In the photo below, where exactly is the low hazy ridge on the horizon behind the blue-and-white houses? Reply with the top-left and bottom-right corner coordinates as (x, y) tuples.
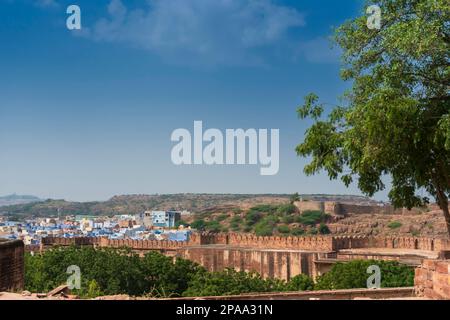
(0, 194), (370, 218)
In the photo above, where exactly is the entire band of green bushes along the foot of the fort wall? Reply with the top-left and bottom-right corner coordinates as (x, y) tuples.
(25, 247), (414, 297)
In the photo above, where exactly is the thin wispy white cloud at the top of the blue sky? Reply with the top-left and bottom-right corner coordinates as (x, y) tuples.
(89, 0), (305, 65)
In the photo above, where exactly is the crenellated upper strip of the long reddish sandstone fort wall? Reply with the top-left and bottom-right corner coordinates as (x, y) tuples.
(36, 232), (450, 251)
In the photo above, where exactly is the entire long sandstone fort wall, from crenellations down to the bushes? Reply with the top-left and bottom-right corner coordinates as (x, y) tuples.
(26, 233), (450, 280)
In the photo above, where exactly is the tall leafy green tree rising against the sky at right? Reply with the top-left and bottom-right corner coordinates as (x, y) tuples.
(296, 0), (450, 234)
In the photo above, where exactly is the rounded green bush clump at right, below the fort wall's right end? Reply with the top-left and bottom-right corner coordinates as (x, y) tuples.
(314, 260), (414, 290)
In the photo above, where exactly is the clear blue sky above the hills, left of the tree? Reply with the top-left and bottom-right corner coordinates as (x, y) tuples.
(0, 0), (385, 201)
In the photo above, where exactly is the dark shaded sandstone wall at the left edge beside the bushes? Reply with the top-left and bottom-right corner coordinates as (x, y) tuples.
(0, 240), (24, 291)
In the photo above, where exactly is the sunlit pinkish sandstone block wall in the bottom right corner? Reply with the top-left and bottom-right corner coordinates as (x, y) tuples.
(414, 260), (450, 299)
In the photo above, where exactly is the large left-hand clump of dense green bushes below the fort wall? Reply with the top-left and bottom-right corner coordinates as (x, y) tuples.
(25, 247), (203, 298)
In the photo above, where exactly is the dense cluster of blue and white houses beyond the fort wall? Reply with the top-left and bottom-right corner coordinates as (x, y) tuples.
(0, 210), (191, 245)
